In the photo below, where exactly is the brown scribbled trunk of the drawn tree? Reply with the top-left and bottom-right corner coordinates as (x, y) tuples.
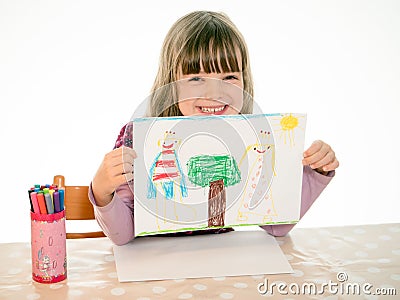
(208, 179), (226, 227)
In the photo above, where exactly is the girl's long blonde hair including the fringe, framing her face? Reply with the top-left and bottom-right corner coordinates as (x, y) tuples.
(146, 11), (253, 117)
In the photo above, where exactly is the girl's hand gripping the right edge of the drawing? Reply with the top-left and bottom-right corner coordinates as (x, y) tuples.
(303, 140), (339, 175)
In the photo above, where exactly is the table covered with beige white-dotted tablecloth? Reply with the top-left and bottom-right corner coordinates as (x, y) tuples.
(0, 224), (400, 300)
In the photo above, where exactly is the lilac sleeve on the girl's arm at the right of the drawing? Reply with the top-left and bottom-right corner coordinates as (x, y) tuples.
(261, 166), (335, 236)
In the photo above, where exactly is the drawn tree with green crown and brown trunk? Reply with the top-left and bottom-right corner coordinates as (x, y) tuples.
(186, 155), (241, 227)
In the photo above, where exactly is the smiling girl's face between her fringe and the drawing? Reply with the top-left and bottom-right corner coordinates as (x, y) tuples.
(177, 71), (243, 116)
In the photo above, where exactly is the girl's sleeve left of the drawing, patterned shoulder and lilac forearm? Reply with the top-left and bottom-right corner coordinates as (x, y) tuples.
(89, 123), (135, 245)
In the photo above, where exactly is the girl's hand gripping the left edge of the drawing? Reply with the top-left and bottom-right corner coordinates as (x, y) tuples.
(92, 146), (137, 206)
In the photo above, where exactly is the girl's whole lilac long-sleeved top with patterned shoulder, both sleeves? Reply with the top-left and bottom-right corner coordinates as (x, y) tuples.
(89, 125), (335, 245)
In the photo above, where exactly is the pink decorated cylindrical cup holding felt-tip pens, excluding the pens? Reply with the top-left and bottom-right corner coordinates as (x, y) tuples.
(31, 210), (67, 283)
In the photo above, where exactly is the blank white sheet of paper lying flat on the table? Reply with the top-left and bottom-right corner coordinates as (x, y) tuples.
(113, 230), (293, 282)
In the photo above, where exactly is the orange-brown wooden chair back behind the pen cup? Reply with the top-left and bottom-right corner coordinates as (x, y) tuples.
(53, 175), (105, 239)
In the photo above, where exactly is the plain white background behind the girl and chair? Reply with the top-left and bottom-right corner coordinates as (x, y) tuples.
(0, 0), (400, 242)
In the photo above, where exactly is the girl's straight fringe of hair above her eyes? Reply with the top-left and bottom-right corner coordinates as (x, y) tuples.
(180, 22), (244, 75)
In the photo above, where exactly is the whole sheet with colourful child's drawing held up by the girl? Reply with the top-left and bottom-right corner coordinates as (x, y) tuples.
(133, 114), (306, 236)
